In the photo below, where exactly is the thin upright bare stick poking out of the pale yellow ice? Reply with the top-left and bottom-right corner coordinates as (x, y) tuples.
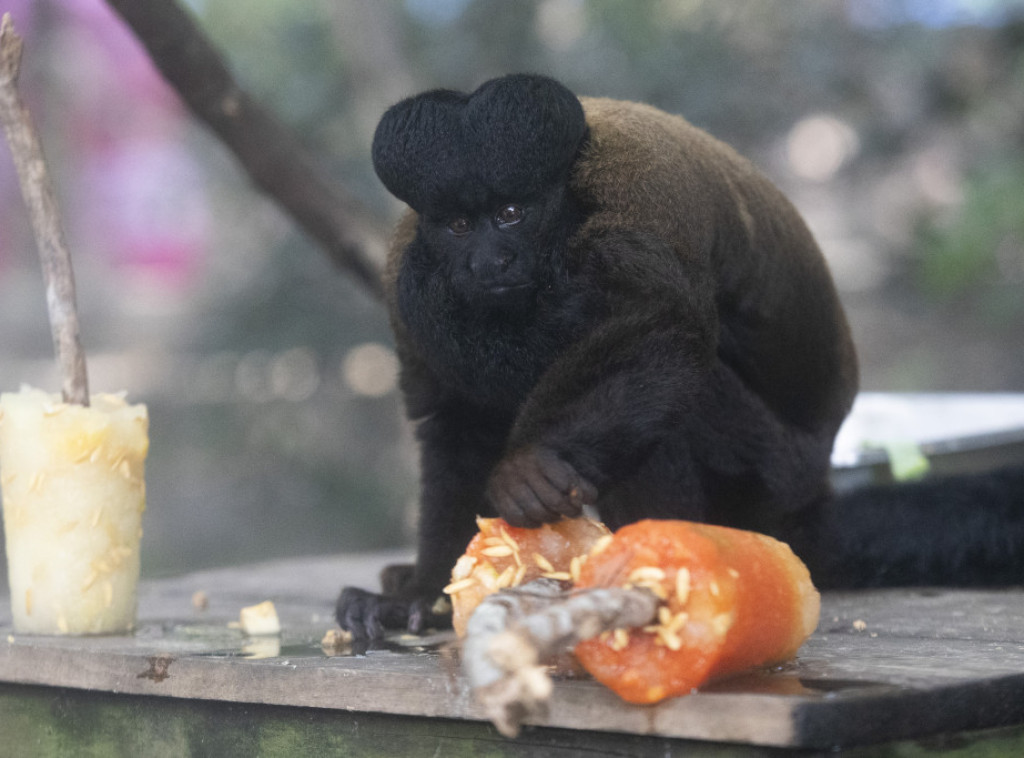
(0, 13), (89, 406)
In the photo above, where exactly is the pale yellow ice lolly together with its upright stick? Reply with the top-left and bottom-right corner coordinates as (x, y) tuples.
(0, 13), (150, 634)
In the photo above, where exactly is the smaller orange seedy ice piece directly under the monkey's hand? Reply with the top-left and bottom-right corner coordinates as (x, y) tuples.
(444, 518), (611, 637)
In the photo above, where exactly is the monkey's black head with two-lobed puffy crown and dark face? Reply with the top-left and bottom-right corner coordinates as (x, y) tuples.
(373, 74), (587, 306)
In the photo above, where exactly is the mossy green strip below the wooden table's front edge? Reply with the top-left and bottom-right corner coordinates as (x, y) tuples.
(0, 684), (806, 758)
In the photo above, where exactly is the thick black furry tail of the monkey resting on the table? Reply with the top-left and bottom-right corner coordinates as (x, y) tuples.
(787, 465), (1024, 589)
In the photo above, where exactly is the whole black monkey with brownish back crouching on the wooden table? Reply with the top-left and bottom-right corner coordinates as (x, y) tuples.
(338, 75), (1024, 637)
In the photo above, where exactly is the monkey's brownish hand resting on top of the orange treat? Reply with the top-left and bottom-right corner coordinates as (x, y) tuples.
(485, 447), (597, 528)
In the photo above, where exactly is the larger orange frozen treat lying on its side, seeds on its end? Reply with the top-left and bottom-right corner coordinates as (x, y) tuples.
(575, 520), (820, 703)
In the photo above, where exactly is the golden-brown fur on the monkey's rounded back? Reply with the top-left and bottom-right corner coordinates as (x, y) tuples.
(572, 97), (857, 434)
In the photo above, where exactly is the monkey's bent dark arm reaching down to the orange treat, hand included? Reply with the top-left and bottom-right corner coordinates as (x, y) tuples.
(486, 231), (718, 527)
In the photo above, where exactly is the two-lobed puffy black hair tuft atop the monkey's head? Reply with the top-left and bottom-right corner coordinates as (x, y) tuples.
(373, 74), (587, 215)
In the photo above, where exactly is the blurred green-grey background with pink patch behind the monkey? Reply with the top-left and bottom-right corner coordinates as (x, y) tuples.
(0, 0), (1024, 581)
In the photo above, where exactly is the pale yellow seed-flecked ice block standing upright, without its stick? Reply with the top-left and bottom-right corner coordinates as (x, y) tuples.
(0, 387), (150, 634)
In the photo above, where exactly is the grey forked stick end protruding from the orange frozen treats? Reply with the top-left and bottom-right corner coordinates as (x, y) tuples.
(462, 579), (659, 736)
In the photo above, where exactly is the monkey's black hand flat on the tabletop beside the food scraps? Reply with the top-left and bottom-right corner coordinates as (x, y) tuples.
(335, 587), (452, 640)
